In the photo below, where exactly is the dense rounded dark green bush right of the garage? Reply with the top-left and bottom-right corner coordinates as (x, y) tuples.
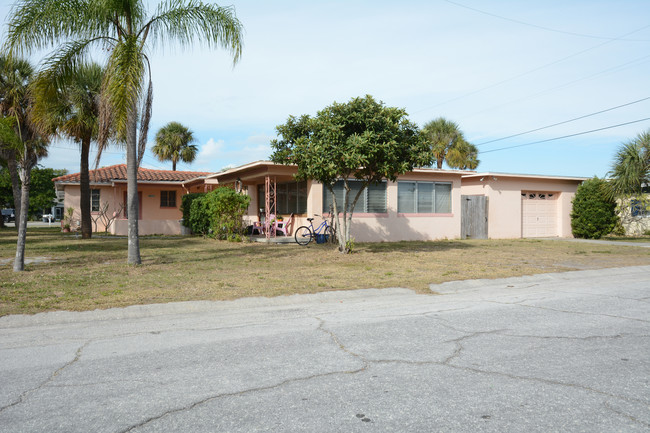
(571, 177), (619, 239)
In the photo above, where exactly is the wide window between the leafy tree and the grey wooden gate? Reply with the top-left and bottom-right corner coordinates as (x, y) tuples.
(397, 182), (451, 213)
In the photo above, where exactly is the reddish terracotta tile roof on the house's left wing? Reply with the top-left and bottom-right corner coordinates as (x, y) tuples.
(52, 164), (211, 183)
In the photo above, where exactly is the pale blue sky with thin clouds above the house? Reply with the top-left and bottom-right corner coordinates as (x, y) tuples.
(0, 0), (650, 177)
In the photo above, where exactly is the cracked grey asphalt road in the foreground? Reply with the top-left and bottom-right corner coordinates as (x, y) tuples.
(0, 266), (650, 433)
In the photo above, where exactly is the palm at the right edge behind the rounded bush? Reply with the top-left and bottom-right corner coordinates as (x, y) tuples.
(608, 129), (650, 196)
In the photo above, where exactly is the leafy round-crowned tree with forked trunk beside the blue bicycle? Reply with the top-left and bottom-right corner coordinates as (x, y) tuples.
(271, 95), (431, 253)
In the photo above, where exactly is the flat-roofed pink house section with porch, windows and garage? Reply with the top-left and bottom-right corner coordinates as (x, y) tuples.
(205, 161), (586, 242)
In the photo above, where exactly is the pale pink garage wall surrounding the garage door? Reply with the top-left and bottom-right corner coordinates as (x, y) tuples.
(462, 174), (579, 239)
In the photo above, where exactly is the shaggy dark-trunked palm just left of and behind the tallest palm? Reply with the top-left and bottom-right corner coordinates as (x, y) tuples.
(32, 63), (103, 239)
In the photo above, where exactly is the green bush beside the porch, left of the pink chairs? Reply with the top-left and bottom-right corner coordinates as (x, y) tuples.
(188, 187), (250, 241)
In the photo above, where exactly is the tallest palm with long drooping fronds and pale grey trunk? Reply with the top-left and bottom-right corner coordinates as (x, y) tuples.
(5, 0), (243, 264)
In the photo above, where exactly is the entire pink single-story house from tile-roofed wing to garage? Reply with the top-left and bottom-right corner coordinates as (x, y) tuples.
(54, 161), (585, 238)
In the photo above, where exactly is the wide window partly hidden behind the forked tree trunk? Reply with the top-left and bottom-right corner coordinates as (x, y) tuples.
(323, 179), (386, 213)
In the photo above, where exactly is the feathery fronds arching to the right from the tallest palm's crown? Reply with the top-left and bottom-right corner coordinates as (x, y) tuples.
(142, 0), (244, 63)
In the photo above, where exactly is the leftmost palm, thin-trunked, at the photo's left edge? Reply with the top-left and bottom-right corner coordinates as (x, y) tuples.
(0, 54), (49, 272)
